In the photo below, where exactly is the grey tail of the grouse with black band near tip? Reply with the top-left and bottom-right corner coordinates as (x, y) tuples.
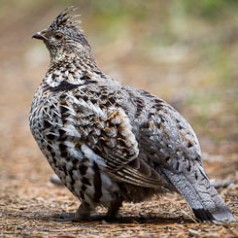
(162, 163), (235, 222)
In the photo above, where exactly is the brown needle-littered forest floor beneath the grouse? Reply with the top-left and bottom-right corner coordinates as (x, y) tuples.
(0, 148), (238, 238)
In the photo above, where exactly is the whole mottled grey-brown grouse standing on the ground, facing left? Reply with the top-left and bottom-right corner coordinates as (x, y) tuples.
(29, 7), (235, 222)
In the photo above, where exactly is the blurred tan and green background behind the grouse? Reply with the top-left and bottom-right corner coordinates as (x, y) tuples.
(0, 0), (238, 186)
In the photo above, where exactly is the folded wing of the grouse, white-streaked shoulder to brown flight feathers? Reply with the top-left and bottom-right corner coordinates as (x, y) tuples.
(60, 93), (164, 188)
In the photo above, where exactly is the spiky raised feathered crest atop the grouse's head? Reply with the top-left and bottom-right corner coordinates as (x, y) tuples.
(50, 6), (81, 29)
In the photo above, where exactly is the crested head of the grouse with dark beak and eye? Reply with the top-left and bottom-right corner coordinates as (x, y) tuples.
(32, 7), (91, 62)
